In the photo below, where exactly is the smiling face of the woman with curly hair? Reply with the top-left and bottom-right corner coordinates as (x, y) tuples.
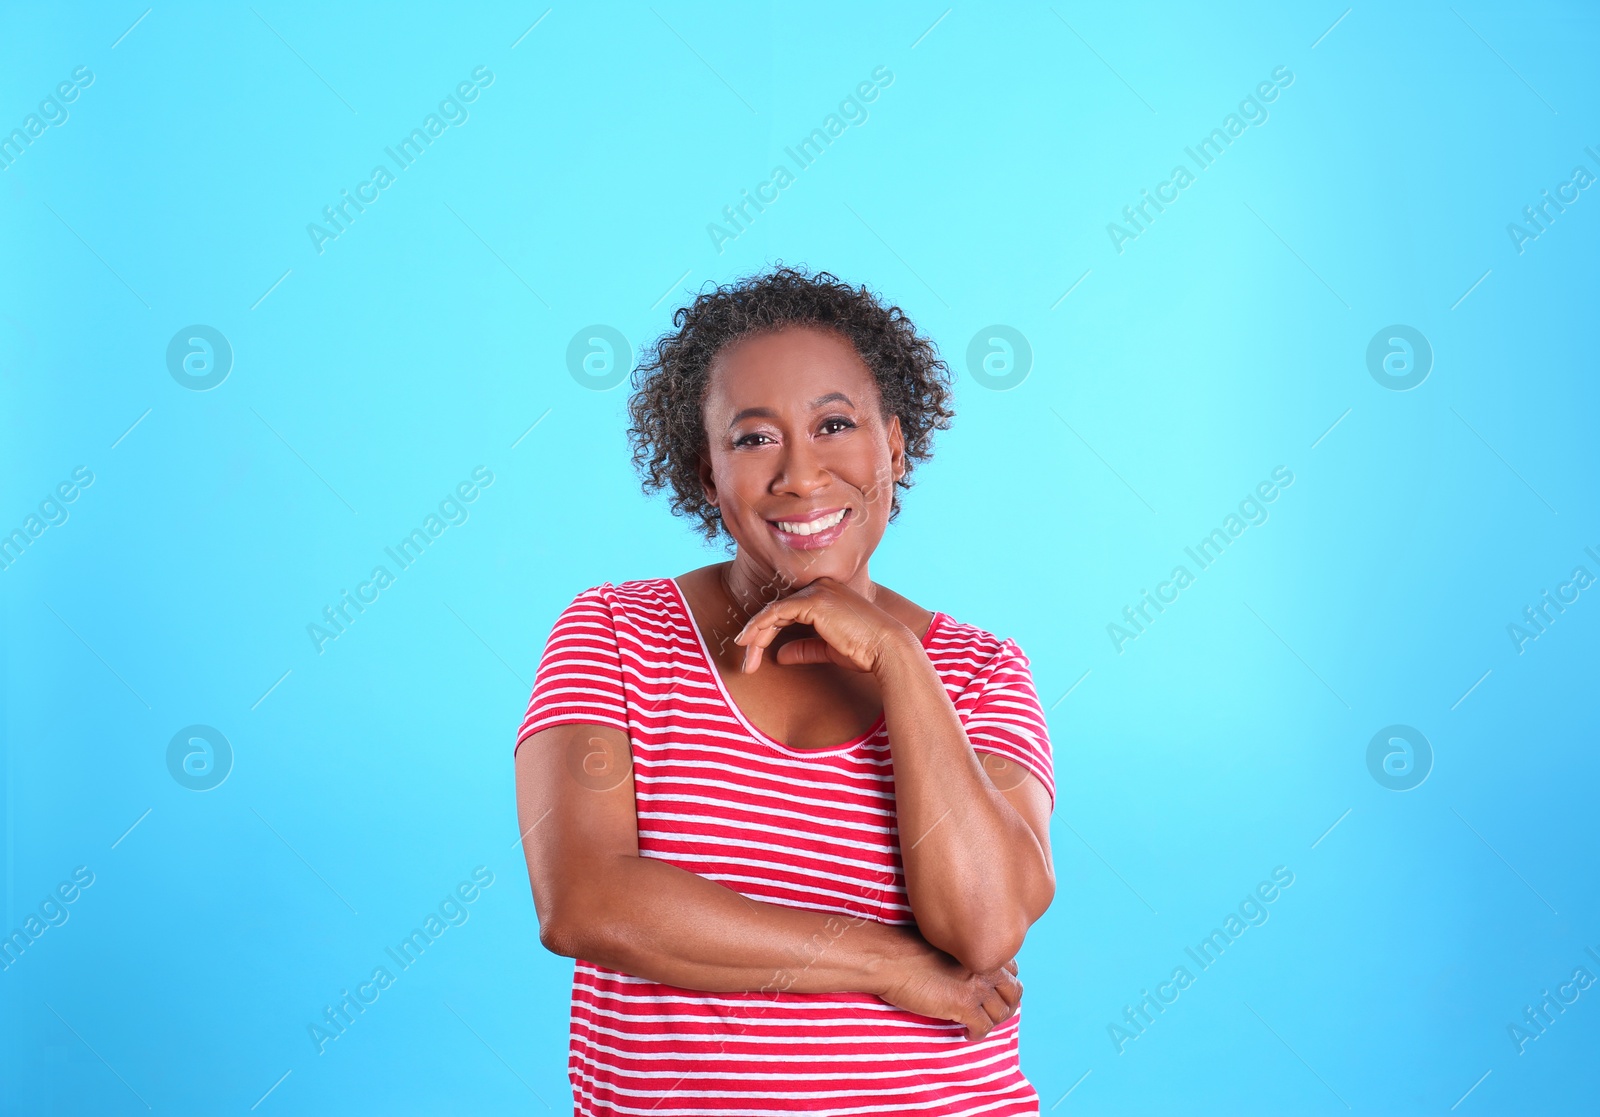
(701, 326), (906, 587)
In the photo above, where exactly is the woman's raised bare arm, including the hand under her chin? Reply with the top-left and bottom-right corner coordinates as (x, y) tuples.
(736, 578), (1056, 973)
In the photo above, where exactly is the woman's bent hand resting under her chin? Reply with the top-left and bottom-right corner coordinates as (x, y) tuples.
(733, 578), (917, 674)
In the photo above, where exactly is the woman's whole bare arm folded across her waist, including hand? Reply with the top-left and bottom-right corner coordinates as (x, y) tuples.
(517, 725), (1021, 1039)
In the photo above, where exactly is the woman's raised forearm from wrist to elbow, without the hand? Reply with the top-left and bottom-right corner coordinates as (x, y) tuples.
(880, 633), (1054, 968)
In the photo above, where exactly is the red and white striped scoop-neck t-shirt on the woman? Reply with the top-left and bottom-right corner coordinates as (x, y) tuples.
(517, 578), (1056, 1117)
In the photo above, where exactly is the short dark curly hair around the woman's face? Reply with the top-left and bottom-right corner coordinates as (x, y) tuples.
(627, 262), (955, 546)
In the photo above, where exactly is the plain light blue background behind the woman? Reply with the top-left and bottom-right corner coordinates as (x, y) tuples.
(0, 0), (1600, 1115)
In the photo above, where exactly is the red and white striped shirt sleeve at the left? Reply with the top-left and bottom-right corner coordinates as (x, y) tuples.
(512, 583), (627, 752)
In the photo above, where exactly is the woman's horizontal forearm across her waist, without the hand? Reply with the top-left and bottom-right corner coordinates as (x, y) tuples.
(542, 856), (914, 995)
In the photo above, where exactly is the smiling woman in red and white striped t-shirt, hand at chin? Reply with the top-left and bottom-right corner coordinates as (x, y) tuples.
(515, 267), (1054, 1115)
